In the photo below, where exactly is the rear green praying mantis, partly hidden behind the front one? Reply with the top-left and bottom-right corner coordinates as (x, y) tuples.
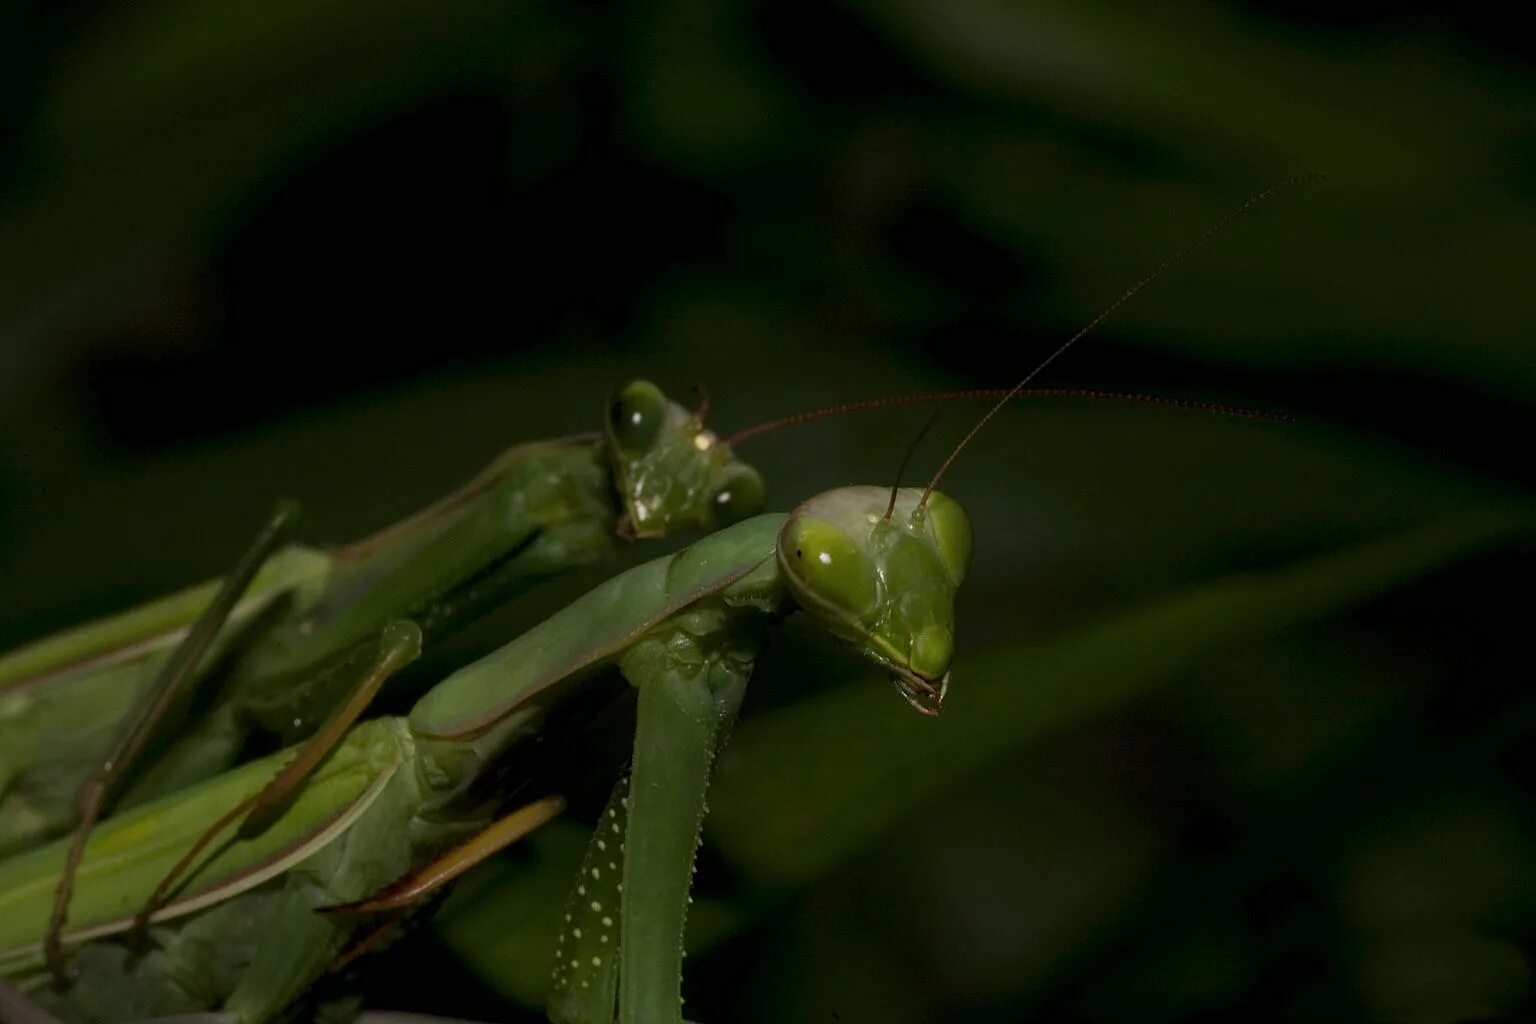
(0, 381), (763, 976)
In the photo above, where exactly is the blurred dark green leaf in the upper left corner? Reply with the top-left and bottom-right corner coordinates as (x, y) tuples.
(0, 0), (544, 329)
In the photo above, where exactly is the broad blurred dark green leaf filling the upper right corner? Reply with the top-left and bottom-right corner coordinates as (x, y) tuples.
(857, 0), (1536, 398)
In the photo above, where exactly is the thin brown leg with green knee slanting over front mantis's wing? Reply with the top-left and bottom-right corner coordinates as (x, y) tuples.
(137, 619), (421, 927)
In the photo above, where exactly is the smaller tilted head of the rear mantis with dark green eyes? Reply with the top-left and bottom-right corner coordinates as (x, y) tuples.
(605, 381), (766, 537)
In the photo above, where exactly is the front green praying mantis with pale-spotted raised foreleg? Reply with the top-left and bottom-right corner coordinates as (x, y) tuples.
(0, 186), (1296, 1024)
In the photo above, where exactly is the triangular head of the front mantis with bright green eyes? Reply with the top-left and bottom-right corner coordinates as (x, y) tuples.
(779, 487), (971, 714)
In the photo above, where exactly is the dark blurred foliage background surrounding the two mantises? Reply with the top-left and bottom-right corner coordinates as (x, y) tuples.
(0, 0), (1536, 1024)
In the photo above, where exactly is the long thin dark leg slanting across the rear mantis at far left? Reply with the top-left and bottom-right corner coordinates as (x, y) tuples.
(43, 502), (298, 983)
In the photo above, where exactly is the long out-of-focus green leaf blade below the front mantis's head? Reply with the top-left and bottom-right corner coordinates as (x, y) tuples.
(707, 513), (1519, 886)
